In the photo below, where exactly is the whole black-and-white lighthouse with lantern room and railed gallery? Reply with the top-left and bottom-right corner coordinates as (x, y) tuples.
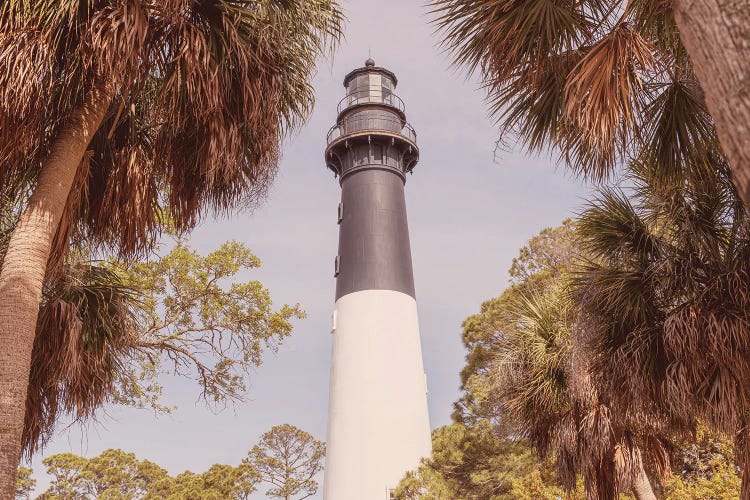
(324, 59), (431, 500)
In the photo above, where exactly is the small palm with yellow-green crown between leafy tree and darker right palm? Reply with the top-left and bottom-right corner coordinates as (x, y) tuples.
(494, 280), (656, 500)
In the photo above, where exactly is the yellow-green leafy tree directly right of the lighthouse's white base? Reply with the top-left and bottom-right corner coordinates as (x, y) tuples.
(397, 228), (583, 500)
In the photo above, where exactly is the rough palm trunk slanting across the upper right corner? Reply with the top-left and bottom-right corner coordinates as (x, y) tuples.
(673, 0), (750, 208)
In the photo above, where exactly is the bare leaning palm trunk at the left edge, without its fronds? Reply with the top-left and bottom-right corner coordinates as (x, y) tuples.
(0, 82), (112, 498)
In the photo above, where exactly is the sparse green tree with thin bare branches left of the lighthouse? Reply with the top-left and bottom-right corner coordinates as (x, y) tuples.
(120, 241), (305, 408)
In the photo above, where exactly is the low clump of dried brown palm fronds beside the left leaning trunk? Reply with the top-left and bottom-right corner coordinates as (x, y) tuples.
(23, 265), (139, 456)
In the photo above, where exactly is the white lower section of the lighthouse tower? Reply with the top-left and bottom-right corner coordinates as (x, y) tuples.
(323, 290), (432, 500)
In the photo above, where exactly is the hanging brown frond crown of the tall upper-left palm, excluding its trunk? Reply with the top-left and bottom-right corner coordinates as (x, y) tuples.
(0, 0), (342, 254)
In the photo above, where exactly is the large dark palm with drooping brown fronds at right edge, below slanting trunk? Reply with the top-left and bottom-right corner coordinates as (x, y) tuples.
(575, 167), (750, 499)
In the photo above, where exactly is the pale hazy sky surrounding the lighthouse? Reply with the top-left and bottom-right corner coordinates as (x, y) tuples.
(27, 0), (590, 499)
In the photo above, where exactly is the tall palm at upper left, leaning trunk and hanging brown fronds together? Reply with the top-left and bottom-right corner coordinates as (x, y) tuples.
(0, 0), (342, 497)
